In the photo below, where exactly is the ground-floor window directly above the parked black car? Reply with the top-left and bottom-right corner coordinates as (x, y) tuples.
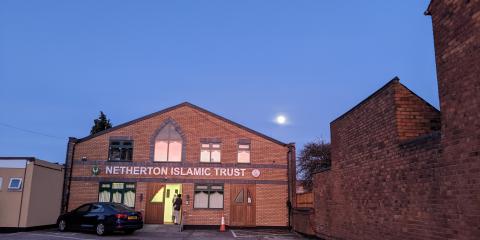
(98, 182), (135, 208)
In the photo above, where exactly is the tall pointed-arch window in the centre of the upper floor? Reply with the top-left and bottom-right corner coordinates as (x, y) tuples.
(153, 123), (182, 162)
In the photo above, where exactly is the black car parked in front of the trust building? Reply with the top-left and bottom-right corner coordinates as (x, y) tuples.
(57, 202), (143, 236)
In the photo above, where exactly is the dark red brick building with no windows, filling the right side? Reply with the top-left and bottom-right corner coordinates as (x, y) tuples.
(294, 0), (480, 239)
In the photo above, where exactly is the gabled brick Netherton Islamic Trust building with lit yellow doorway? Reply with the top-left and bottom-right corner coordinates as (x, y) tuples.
(64, 103), (295, 227)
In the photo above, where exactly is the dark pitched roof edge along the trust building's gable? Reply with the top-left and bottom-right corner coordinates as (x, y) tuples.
(70, 102), (288, 146)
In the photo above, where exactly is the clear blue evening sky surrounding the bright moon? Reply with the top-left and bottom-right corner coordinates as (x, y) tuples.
(0, 0), (438, 162)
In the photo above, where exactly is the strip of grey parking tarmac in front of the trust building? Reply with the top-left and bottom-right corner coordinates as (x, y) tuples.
(0, 226), (304, 240)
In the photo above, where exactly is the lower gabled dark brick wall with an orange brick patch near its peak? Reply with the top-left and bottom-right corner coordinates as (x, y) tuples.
(314, 80), (439, 239)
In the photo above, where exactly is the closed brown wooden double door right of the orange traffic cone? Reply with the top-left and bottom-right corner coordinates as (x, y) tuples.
(230, 184), (257, 227)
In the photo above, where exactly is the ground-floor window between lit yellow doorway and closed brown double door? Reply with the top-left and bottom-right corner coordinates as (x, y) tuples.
(193, 185), (223, 209)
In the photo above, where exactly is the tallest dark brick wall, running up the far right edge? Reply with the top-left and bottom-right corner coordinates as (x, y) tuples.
(429, 0), (480, 239)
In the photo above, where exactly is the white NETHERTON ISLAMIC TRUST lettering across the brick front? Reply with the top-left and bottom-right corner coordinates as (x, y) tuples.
(105, 166), (253, 177)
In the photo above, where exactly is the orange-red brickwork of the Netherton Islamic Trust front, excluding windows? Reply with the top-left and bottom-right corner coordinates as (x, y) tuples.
(69, 105), (289, 226)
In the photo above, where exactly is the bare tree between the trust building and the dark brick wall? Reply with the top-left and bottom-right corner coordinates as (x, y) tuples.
(297, 140), (331, 191)
